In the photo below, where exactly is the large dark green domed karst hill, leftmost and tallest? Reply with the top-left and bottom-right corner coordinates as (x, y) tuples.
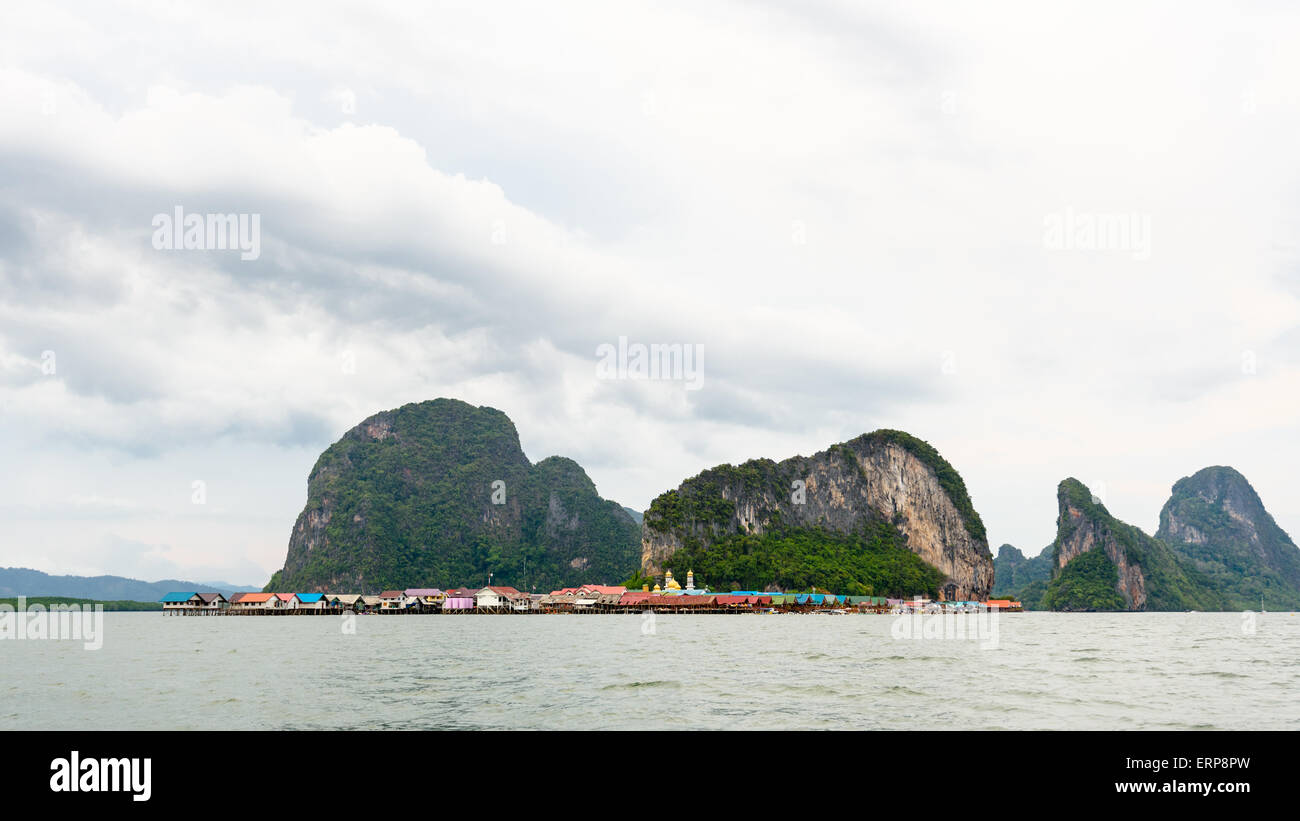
(267, 399), (641, 594)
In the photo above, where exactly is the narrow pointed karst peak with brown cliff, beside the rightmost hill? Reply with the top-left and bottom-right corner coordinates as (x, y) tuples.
(1043, 479), (1225, 611)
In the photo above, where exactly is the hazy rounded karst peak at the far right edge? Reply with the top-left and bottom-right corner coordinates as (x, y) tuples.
(1156, 466), (1300, 609)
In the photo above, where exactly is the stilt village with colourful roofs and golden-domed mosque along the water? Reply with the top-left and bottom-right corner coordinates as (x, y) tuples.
(161, 570), (1022, 616)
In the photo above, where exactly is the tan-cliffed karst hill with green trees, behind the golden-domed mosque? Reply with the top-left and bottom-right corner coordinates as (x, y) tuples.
(641, 430), (993, 599)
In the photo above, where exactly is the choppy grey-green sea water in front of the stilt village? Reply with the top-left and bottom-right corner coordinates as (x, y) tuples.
(0, 612), (1300, 730)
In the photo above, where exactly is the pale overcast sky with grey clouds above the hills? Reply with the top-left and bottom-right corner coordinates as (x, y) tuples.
(0, 0), (1300, 585)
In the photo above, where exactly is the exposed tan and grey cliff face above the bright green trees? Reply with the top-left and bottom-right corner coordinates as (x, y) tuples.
(641, 431), (993, 599)
